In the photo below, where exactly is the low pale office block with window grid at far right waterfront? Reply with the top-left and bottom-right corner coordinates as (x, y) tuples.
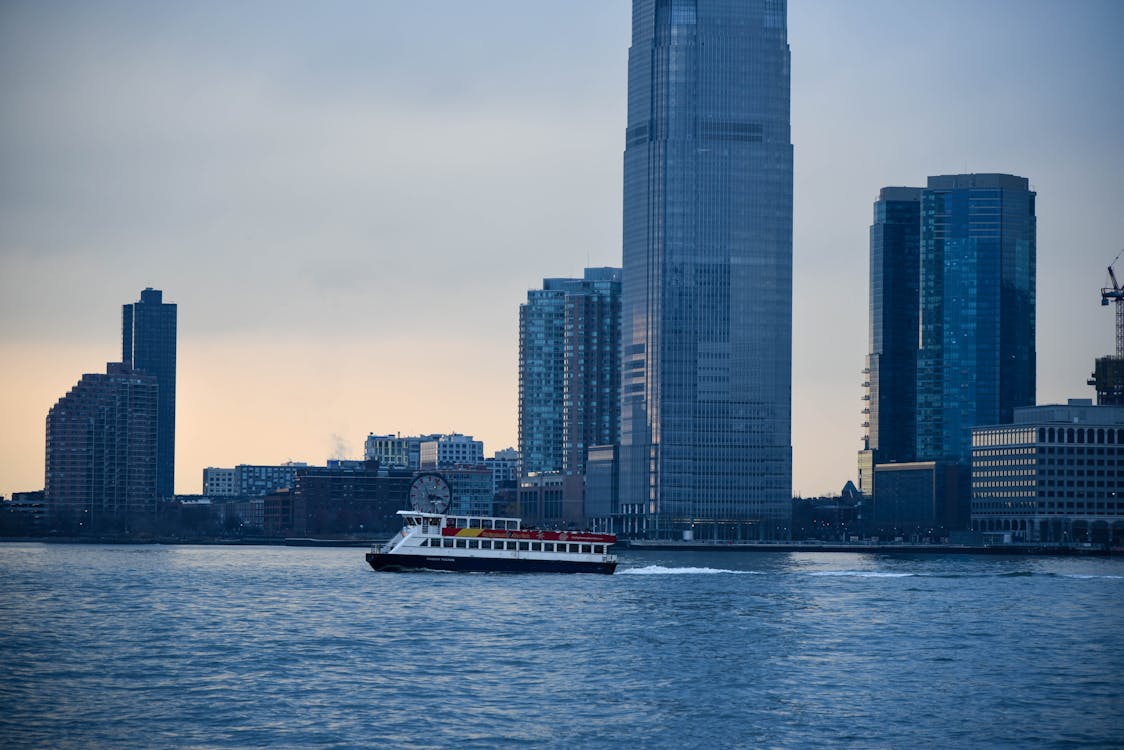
(971, 399), (1124, 545)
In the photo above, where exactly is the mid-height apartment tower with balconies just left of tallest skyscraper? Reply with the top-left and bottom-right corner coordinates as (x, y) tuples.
(518, 268), (620, 476)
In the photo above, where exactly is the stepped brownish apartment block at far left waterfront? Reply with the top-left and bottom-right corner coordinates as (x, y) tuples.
(44, 362), (158, 531)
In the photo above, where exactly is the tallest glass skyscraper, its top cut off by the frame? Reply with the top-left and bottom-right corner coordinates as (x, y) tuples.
(619, 0), (792, 539)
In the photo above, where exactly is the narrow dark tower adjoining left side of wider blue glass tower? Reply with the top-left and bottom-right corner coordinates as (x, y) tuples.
(859, 188), (922, 496)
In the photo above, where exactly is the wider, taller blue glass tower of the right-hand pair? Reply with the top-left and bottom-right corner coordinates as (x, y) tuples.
(917, 174), (1036, 463)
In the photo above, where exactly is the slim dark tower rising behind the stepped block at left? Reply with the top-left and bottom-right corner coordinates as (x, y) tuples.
(121, 288), (176, 498)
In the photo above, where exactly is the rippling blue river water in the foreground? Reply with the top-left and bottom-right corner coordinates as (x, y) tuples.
(0, 544), (1124, 749)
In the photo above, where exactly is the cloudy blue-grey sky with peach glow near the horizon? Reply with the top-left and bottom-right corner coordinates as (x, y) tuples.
(0, 0), (1124, 496)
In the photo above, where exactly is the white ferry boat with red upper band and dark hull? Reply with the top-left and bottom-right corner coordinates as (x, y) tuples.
(366, 509), (617, 573)
